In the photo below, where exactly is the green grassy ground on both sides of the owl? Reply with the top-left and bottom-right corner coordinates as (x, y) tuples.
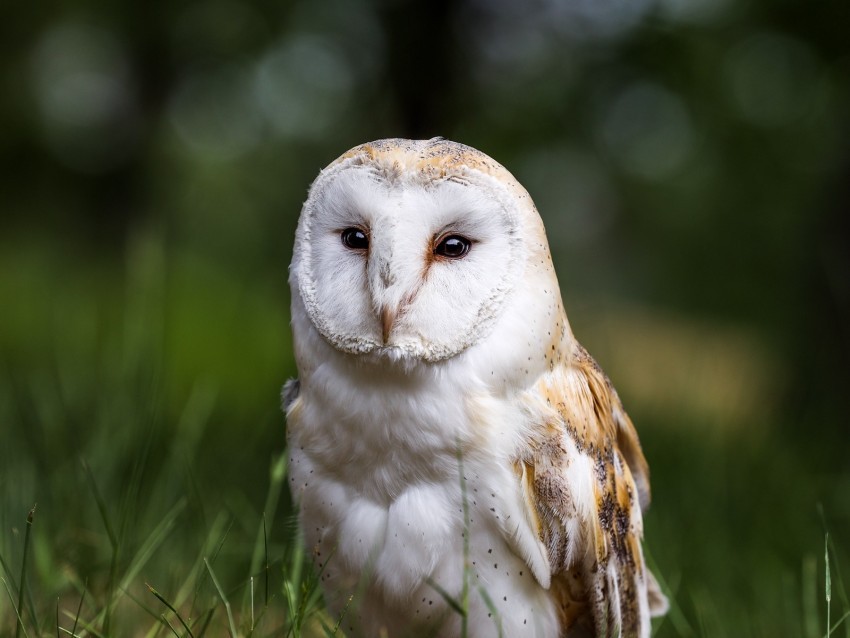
(0, 236), (850, 638)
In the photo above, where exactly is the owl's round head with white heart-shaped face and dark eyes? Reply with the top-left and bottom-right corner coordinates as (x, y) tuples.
(290, 138), (550, 362)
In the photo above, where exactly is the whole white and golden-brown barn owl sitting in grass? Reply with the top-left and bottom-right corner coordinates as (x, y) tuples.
(283, 138), (667, 638)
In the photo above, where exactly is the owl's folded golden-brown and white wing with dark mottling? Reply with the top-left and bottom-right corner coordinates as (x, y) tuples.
(518, 343), (667, 637)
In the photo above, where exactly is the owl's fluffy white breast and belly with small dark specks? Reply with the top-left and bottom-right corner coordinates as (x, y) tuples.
(288, 332), (555, 637)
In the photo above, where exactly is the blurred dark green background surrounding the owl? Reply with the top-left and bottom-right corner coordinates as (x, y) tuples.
(0, 0), (850, 638)
